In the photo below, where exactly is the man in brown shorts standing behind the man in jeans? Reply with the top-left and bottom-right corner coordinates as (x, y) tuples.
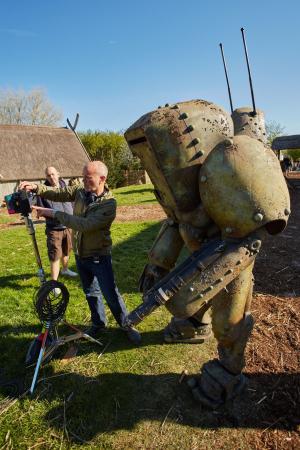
(38, 167), (77, 280)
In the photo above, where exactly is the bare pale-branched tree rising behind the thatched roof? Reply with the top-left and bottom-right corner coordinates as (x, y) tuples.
(0, 89), (62, 126)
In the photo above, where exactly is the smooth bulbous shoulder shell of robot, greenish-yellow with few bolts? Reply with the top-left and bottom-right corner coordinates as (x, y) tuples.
(199, 135), (290, 238)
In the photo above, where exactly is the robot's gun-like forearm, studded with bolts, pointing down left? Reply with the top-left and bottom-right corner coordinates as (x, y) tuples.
(128, 229), (266, 325)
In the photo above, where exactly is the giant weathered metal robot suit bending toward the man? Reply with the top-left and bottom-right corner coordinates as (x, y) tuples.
(125, 100), (290, 407)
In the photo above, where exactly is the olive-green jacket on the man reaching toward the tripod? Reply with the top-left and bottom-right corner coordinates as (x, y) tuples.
(37, 184), (117, 258)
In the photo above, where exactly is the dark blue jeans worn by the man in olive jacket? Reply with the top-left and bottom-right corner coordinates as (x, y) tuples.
(75, 255), (128, 327)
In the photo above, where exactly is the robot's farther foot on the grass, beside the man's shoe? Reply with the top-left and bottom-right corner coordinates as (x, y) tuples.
(164, 317), (212, 344)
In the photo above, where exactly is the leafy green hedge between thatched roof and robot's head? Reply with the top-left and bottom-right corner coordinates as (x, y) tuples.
(79, 130), (141, 188)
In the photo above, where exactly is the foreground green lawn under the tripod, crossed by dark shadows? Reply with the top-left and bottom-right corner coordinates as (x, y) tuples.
(0, 222), (264, 449)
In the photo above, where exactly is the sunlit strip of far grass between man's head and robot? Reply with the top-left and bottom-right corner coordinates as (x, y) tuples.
(113, 184), (157, 206)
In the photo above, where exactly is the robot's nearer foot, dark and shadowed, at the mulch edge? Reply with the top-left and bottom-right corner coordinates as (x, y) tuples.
(187, 359), (246, 409)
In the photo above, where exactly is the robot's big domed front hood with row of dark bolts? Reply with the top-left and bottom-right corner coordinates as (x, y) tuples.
(125, 100), (233, 216)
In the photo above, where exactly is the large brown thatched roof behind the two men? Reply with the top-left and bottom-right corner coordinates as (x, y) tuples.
(0, 125), (89, 183)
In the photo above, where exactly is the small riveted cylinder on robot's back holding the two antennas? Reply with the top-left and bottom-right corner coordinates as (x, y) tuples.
(231, 108), (267, 144)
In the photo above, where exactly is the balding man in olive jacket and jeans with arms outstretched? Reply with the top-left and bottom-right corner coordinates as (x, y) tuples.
(20, 161), (141, 345)
